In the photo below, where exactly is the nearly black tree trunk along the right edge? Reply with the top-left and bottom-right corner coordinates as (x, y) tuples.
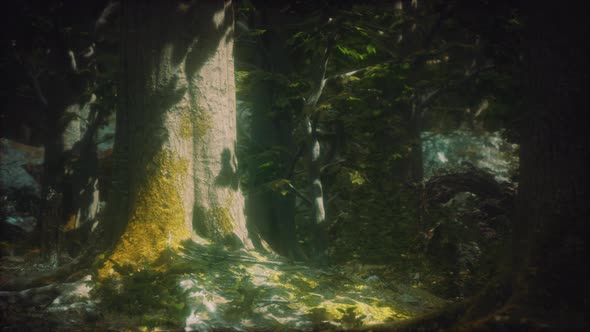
(456, 1), (590, 330)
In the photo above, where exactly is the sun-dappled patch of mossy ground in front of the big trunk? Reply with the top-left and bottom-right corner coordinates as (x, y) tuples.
(92, 242), (445, 331)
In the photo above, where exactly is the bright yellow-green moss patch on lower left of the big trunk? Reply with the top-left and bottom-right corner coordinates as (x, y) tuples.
(98, 150), (191, 279)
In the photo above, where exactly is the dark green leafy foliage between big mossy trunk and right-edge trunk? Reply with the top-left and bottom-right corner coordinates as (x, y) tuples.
(238, 1), (522, 306)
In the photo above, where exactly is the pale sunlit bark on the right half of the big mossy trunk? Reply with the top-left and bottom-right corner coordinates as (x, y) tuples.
(187, 3), (252, 247)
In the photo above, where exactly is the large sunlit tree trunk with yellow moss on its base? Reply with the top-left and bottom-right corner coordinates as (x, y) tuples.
(101, 1), (252, 272)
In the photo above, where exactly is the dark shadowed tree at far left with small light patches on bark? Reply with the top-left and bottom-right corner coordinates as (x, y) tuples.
(2, 1), (117, 264)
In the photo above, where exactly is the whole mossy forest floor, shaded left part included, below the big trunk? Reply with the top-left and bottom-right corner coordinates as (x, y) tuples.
(0, 243), (448, 331)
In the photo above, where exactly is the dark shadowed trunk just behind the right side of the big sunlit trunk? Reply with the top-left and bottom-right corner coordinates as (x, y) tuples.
(238, 5), (302, 260)
